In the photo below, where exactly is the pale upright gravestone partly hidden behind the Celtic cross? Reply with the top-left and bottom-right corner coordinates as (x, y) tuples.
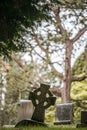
(18, 100), (34, 121)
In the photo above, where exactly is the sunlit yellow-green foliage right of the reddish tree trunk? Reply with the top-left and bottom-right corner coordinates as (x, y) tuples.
(71, 49), (87, 122)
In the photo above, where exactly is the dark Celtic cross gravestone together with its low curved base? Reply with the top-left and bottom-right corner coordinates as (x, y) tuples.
(16, 84), (56, 127)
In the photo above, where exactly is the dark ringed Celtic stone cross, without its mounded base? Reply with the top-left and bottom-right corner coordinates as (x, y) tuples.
(29, 84), (56, 122)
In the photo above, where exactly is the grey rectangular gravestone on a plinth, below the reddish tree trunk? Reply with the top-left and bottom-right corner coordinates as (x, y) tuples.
(54, 103), (73, 125)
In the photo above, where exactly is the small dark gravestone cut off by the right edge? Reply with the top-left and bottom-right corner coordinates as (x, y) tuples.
(77, 110), (87, 128)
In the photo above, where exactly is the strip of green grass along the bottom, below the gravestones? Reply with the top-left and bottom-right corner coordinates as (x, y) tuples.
(0, 125), (87, 130)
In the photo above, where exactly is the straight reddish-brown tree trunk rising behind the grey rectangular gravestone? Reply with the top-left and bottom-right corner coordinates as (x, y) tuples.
(61, 41), (72, 103)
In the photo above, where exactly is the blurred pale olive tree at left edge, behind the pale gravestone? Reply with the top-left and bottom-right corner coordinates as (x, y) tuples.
(0, 55), (35, 125)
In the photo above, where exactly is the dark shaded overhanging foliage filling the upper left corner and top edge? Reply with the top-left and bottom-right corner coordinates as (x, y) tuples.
(0, 0), (85, 56)
